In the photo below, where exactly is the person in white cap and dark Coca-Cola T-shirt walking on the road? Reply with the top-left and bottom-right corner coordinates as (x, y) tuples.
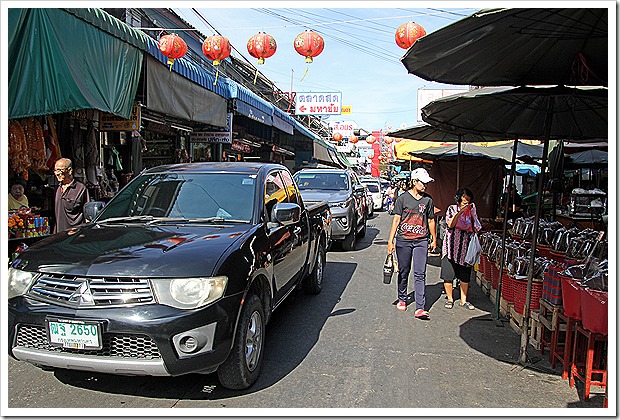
(387, 168), (437, 319)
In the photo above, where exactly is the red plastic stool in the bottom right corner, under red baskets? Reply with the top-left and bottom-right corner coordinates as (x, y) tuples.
(569, 323), (607, 401)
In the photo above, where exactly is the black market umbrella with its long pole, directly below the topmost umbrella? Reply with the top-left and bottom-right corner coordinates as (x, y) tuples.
(421, 86), (608, 363)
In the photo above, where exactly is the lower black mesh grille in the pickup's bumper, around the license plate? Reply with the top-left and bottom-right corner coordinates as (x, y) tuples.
(16, 325), (161, 359)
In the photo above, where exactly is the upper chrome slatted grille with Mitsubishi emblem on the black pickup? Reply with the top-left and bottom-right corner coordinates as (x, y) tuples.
(28, 273), (154, 308)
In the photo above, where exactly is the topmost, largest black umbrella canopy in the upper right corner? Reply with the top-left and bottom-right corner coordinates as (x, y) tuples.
(401, 8), (613, 86)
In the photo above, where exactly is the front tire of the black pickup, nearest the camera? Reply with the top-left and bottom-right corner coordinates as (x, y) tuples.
(217, 295), (265, 389)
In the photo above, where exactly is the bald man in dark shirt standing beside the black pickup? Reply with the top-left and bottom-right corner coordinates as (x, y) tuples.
(54, 158), (89, 233)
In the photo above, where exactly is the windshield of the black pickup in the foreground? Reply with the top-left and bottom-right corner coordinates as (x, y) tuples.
(97, 173), (256, 222)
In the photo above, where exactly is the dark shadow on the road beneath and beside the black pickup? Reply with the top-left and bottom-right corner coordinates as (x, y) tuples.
(54, 260), (358, 400)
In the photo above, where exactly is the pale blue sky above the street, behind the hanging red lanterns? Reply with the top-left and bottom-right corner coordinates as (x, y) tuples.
(174, 1), (480, 131)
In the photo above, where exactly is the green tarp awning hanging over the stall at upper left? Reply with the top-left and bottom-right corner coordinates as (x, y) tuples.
(8, 8), (146, 119)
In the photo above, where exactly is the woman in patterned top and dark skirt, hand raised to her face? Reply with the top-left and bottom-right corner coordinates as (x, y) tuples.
(440, 188), (482, 309)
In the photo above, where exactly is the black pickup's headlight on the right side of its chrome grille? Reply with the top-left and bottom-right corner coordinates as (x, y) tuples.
(151, 276), (228, 309)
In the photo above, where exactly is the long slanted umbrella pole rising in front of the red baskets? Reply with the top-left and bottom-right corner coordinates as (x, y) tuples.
(516, 97), (553, 366)
